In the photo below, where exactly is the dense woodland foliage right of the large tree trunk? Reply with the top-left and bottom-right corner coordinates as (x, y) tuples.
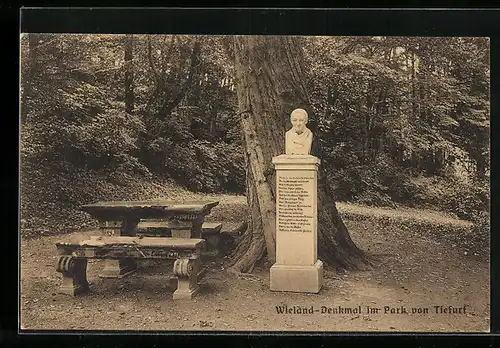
(304, 37), (489, 219)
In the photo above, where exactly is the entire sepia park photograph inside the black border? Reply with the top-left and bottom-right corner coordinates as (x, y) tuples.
(19, 33), (490, 333)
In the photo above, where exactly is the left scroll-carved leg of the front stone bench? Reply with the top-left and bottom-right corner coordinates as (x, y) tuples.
(57, 255), (89, 296)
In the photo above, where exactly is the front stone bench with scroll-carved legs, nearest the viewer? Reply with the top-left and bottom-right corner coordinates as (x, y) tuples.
(56, 236), (205, 300)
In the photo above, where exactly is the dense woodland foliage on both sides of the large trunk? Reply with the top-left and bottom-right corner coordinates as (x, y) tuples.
(20, 34), (490, 239)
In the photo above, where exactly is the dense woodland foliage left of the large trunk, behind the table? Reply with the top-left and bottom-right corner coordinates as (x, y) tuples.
(20, 34), (245, 237)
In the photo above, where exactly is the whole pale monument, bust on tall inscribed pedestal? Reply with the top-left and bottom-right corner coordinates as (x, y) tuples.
(271, 109), (323, 293)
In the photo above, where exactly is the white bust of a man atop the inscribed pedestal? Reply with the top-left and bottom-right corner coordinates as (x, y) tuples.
(285, 109), (312, 155)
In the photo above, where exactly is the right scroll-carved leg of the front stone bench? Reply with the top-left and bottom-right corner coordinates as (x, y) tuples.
(173, 259), (200, 300)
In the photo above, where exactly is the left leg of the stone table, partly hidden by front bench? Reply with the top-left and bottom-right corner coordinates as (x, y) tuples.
(99, 221), (137, 278)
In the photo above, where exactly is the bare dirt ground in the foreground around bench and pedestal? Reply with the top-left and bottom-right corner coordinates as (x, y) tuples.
(21, 204), (490, 332)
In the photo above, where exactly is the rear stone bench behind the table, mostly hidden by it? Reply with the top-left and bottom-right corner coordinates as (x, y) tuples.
(136, 220), (222, 256)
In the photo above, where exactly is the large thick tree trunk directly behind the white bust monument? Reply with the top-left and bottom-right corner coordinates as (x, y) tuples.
(230, 36), (370, 272)
